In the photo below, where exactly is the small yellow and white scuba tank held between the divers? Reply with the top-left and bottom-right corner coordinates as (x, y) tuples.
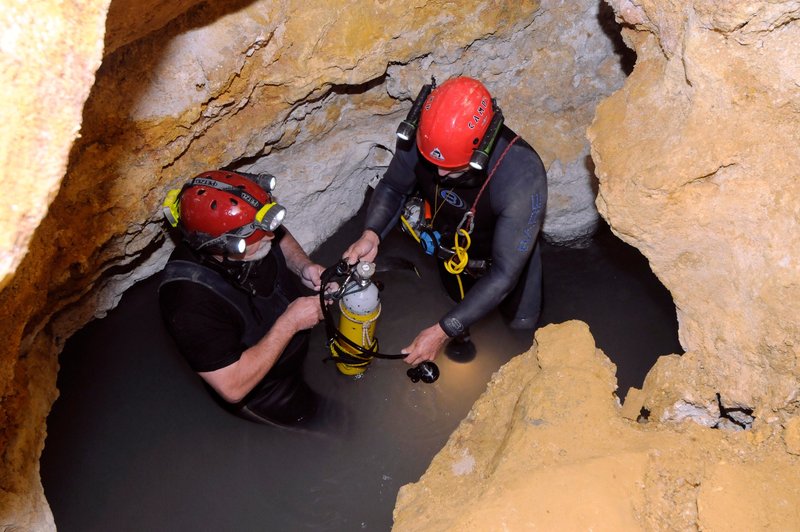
(331, 262), (381, 375)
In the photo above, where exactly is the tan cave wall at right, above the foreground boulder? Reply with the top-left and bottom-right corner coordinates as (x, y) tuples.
(589, 0), (800, 426)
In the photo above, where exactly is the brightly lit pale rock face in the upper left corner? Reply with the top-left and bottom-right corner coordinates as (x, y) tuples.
(0, 0), (110, 290)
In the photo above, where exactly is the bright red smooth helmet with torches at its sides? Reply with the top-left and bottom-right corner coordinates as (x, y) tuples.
(417, 77), (494, 169)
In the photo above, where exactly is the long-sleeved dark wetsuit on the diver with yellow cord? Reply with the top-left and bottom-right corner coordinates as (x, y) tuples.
(365, 126), (547, 336)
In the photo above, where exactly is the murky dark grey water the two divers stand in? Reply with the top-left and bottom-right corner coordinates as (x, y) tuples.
(41, 208), (681, 532)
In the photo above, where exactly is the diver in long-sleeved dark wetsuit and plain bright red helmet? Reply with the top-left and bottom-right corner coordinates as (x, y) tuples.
(343, 77), (547, 364)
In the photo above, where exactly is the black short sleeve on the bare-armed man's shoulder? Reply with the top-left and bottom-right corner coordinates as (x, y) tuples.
(159, 281), (247, 372)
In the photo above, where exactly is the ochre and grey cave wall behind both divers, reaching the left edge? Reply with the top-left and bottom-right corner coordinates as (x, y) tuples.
(0, 0), (624, 529)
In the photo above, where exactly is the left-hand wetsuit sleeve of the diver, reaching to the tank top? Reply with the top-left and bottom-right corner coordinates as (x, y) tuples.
(364, 142), (418, 240)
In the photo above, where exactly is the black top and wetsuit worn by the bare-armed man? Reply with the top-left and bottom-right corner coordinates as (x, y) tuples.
(159, 233), (316, 425)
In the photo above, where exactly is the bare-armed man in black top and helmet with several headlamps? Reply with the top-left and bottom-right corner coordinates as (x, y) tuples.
(159, 171), (323, 426)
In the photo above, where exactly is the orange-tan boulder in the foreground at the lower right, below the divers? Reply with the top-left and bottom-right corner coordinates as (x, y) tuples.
(393, 322), (800, 532)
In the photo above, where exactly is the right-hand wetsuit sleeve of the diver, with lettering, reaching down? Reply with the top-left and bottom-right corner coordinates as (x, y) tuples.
(439, 146), (547, 337)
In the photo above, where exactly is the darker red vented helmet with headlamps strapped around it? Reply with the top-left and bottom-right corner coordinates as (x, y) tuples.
(164, 170), (286, 251)
